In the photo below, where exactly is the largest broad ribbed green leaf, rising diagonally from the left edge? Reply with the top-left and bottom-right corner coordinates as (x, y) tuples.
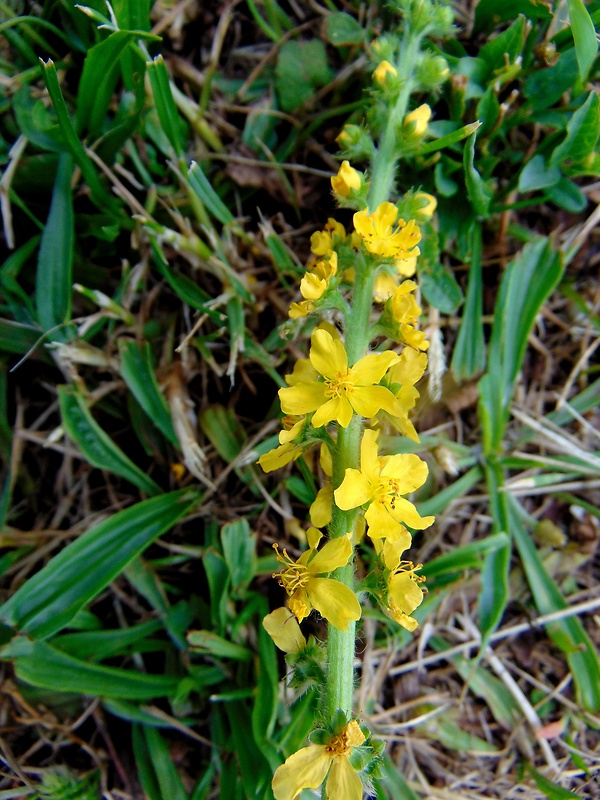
(0, 489), (200, 638)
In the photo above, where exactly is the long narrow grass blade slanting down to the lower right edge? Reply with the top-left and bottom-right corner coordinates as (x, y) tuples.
(508, 497), (600, 713)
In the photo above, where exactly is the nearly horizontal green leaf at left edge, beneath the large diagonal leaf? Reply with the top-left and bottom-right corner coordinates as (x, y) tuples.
(0, 636), (179, 700)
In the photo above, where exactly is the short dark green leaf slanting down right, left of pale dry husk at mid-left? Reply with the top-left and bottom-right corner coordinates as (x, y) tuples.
(119, 339), (179, 447)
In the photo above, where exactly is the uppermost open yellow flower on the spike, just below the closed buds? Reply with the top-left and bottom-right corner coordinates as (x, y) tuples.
(354, 202), (421, 259)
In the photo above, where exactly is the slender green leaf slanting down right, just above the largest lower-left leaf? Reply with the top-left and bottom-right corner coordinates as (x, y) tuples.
(58, 386), (162, 495)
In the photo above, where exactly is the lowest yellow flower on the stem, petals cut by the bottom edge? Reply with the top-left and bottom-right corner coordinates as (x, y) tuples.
(271, 719), (365, 800)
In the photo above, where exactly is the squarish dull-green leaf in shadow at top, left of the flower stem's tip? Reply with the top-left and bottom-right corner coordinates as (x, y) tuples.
(275, 39), (332, 111)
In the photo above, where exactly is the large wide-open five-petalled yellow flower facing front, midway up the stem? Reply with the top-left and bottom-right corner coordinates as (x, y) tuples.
(279, 328), (400, 428)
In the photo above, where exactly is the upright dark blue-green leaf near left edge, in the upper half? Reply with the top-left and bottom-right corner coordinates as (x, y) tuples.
(35, 153), (75, 339)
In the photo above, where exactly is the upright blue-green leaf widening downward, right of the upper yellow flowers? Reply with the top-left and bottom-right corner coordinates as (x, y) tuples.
(451, 223), (485, 380)
